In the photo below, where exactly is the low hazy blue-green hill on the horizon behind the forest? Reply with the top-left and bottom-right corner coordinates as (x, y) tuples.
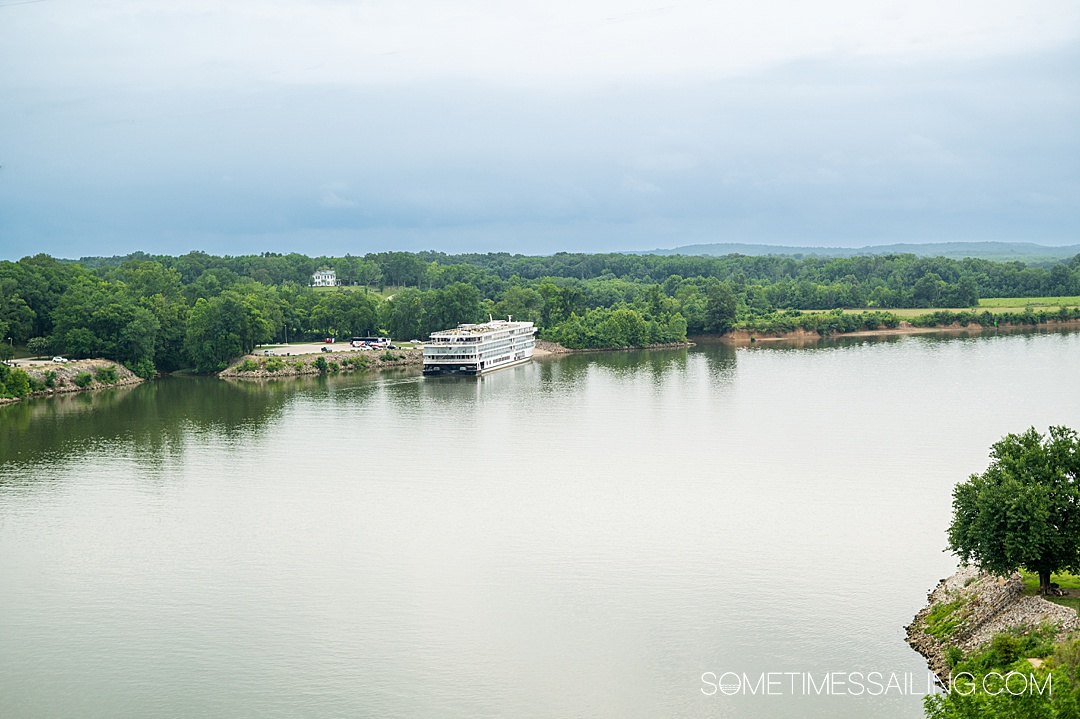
(631, 242), (1080, 262)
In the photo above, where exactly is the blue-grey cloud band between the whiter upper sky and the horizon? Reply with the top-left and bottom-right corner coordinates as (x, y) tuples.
(0, 43), (1080, 257)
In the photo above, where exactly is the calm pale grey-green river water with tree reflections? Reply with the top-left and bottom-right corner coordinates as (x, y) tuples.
(0, 334), (1080, 719)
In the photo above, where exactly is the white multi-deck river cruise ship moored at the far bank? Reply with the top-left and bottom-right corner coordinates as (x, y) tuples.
(423, 317), (536, 375)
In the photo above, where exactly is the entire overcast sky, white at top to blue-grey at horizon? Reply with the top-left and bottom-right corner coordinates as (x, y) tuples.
(0, 0), (1080, 259)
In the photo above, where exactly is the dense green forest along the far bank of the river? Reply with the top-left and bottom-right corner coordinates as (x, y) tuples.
(0, 252), (1080, 377)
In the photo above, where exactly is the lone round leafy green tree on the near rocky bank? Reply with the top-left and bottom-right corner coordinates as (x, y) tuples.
(948, 426), (1080, 594)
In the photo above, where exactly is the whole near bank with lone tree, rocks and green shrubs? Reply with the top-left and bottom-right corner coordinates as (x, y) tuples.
(905, 425), (1080, 719)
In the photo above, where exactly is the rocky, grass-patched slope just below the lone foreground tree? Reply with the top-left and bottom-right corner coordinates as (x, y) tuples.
(905, 567), (1080, 681)
